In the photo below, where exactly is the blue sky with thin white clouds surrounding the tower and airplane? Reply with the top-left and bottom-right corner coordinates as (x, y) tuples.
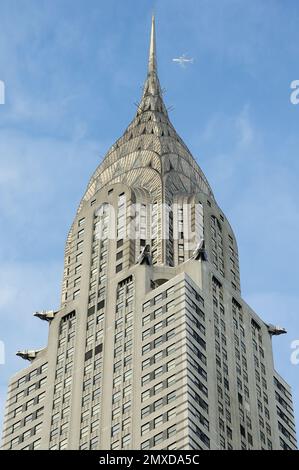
(0, 0), (299, 440)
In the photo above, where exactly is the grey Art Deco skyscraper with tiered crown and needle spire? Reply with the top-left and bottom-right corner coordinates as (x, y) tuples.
(2, 18), (296, 449)
